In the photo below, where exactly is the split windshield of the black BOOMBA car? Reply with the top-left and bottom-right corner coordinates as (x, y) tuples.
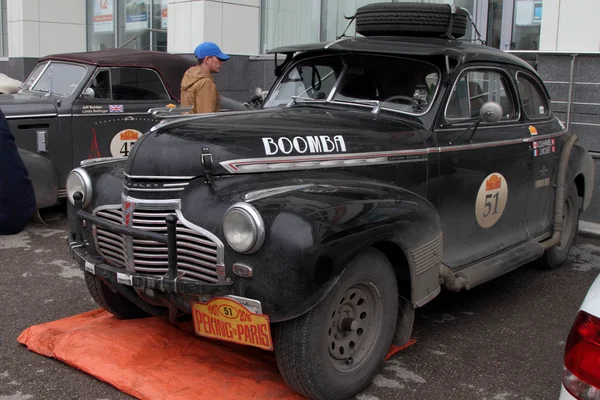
(264, 55), (440, 114)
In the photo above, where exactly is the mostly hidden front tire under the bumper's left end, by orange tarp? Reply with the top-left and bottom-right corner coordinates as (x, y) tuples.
(85, 272), (149, 319)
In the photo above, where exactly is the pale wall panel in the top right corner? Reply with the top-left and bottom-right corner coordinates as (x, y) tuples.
(540, 0), (600, 51)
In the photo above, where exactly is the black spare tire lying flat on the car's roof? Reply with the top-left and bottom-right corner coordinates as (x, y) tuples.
(356, 3), (468, 39)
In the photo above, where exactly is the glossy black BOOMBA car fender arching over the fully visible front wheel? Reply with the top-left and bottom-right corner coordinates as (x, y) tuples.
(176, 177), (442, 322)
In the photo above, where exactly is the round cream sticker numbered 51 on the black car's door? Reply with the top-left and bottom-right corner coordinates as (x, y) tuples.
(475, 172), (508, 228)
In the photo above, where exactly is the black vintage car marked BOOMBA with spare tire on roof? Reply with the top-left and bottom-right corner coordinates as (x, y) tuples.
(67, 3), (594, 399)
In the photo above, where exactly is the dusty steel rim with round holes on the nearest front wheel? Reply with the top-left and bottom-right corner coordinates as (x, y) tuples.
(325, 281), (383, 373)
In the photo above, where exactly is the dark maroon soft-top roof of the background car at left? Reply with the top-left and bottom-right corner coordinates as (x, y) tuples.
(39, 49), (196, 100)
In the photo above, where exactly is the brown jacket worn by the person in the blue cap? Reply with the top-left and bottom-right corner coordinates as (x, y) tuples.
(181, 65), (220, 114)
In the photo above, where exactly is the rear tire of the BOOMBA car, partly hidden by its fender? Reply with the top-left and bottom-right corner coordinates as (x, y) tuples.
(539, 183), (580, 269)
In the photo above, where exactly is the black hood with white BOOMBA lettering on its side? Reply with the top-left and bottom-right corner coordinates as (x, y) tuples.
(126, 106), (424, 177)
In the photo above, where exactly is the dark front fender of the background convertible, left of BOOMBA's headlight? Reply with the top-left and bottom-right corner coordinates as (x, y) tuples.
(18, 149), (58, 209)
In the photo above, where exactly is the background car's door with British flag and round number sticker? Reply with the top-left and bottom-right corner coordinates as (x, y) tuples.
(73, 67), (174, 164)
